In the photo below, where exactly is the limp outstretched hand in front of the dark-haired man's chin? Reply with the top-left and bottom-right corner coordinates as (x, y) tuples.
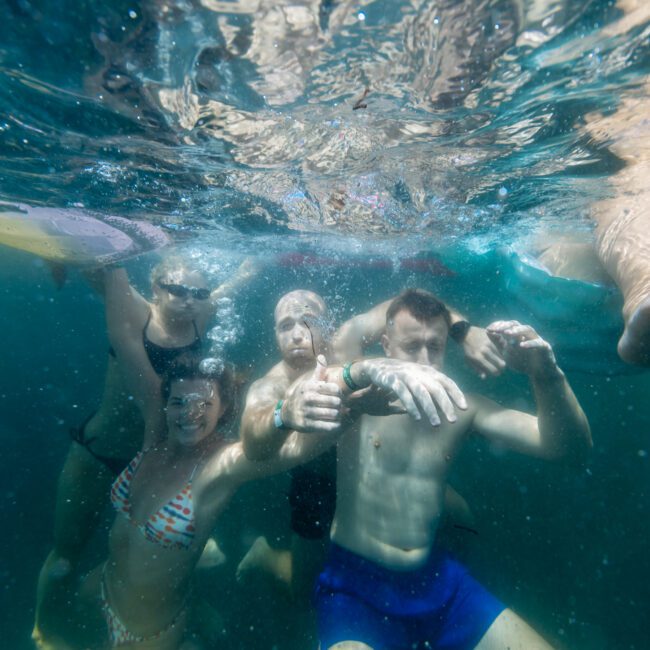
(359, 358), (467, 426)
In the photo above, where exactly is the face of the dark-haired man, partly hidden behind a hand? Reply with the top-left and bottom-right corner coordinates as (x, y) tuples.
(382, 309), (449, 370)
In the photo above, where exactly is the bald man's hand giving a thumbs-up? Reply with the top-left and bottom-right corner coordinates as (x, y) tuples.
(282, 354), (343, 433)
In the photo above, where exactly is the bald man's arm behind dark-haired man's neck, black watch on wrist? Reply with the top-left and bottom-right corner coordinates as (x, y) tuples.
(332, 298), (505, 377)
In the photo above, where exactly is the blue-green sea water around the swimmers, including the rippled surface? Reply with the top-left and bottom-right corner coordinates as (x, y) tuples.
(0, 0), (650, 650)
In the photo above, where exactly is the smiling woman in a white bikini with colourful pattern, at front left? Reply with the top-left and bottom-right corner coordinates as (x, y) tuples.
(84, 349), (334, 650)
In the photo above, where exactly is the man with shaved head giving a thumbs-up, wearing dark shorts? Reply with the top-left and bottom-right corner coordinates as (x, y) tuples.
(239, 290), (342, 599)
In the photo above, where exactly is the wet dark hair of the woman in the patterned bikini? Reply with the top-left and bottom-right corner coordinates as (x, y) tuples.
(160, 354), (236, 424)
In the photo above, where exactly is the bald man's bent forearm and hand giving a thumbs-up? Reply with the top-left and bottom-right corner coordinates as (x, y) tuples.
(240, 355), (342, 460)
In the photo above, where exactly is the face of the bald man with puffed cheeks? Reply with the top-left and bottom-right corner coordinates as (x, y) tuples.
(275, 291), (326, 370)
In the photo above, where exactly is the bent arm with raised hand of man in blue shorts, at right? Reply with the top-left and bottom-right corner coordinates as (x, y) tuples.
(473, 321), (592, 463)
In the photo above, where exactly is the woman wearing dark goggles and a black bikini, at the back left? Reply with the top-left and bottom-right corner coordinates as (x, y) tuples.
(32, 255), (256, 647)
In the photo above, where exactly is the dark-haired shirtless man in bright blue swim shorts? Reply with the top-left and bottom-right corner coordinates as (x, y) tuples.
(316, 289), (591, 650)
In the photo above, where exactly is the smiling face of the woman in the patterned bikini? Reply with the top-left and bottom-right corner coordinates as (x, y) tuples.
(166, 378), (225, 447)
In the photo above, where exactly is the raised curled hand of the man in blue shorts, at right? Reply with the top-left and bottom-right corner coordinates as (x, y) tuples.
(486, 320), (560, 377)
